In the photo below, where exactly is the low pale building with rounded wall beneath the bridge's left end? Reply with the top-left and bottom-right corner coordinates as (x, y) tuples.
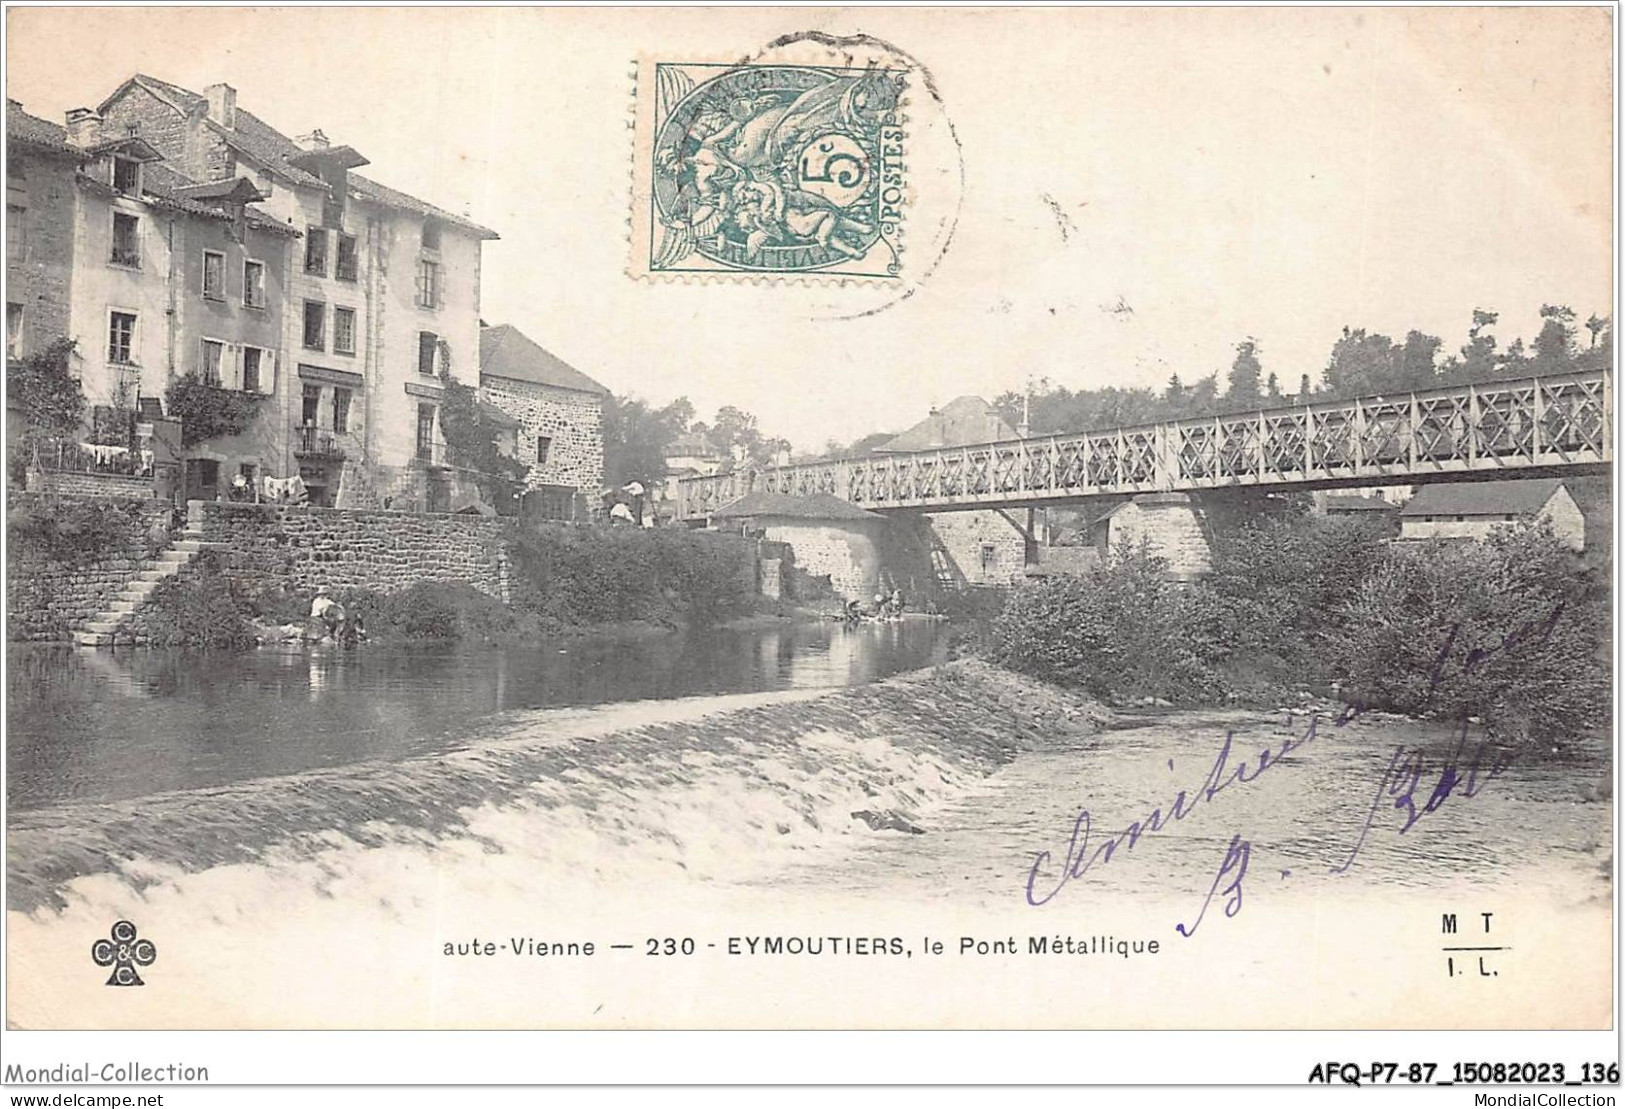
(712, 493), (886, 600)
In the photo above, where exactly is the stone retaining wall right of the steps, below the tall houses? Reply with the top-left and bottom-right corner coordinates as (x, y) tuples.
(189, 501), (514, 600)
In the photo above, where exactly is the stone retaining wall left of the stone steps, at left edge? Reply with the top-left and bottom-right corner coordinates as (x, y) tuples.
(7, 493), (171, 639)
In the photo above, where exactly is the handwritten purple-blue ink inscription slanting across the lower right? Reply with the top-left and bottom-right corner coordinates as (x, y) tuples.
(1027, 603), (1563, 937)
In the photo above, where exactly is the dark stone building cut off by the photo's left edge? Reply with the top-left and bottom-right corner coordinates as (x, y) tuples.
(5, 99), (85, 358)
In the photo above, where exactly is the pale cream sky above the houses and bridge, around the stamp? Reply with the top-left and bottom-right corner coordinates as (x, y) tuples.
(7, 8), (1614, 450)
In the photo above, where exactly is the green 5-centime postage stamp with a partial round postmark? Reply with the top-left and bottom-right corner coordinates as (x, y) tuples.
(632, 62), (907, 280)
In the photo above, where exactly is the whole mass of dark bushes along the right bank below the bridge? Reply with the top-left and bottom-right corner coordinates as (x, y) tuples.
(983, 517), (1609, 740)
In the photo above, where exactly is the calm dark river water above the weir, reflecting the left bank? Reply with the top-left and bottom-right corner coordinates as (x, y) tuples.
(7, 621), (946, 810)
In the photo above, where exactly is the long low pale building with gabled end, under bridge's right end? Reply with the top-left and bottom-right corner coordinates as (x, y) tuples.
(1399, 478), (1586, 551)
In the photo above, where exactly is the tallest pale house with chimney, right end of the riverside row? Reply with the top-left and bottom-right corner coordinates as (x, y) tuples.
(81, 73), (497, 511)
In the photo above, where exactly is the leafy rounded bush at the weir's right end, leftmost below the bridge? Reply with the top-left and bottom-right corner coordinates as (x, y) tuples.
(988, 546), (1225, 704)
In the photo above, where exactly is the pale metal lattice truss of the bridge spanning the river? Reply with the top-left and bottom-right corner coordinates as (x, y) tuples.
(678, 371), (1614, 519)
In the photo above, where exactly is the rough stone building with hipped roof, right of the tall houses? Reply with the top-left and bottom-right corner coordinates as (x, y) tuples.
(479, 324), (609, 520)
